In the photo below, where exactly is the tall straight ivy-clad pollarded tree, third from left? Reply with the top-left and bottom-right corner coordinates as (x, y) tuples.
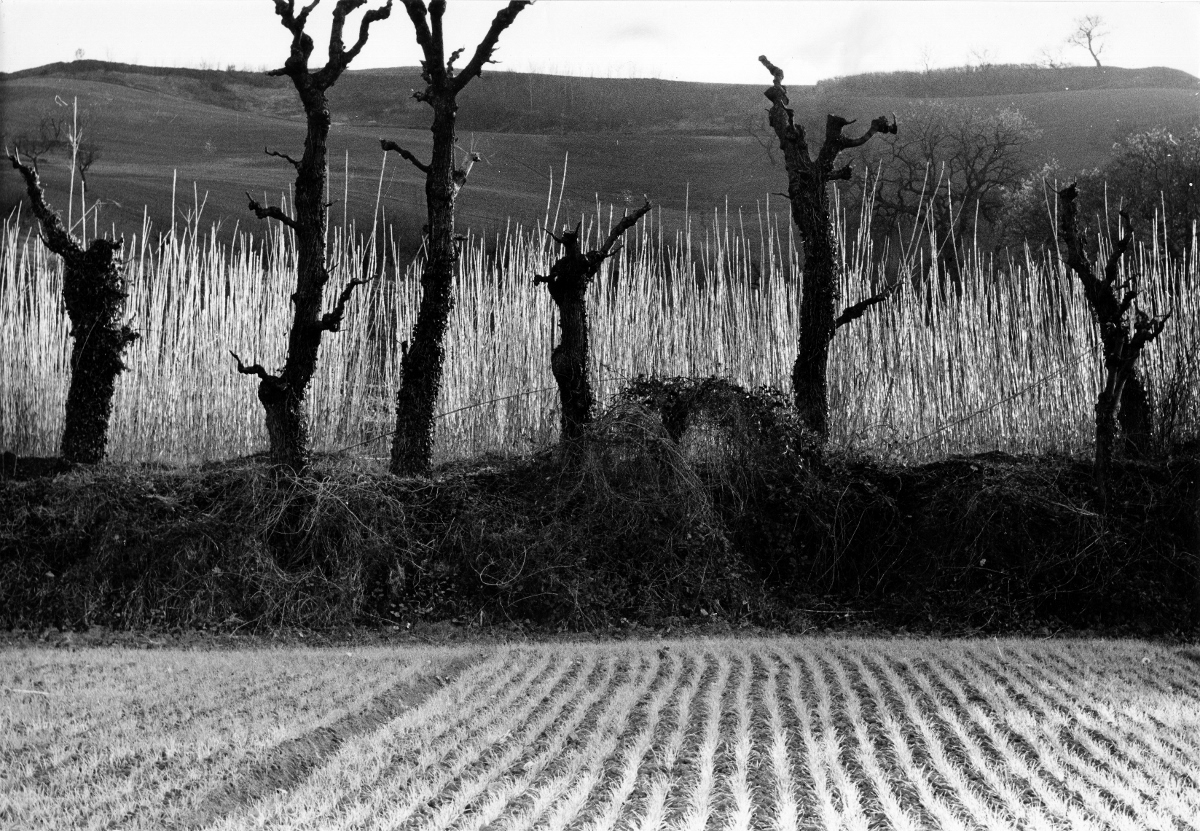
(379, 0), (529, 476)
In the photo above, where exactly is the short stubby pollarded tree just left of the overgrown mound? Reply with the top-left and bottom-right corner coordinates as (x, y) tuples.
(534, 202), (650, 442)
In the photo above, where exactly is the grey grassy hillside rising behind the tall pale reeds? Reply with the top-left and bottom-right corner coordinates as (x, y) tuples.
(0, 61), (1200, 248)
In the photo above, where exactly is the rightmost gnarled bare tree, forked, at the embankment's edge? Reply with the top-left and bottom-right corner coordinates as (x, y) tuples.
(1058, 185), (1171, 508)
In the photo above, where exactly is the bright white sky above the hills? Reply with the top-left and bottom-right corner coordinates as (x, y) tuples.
(0, 0), (1200, 84)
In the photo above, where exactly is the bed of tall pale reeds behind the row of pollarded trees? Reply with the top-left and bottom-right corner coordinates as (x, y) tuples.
(0, 196), (1200, 464)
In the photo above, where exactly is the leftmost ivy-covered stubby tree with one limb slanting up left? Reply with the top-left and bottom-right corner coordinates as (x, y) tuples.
(8, 154), (138, 465)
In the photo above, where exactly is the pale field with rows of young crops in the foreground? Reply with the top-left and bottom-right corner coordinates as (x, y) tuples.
(0, 640), (1200, 830)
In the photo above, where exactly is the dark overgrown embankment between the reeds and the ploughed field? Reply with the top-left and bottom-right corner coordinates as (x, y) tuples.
(0, 381), (1200, 634)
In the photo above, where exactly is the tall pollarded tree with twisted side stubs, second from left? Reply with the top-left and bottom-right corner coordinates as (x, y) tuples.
(234, 0), (391, 473)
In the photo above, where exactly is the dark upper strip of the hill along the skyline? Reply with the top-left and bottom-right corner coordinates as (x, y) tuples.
(0, 60), (1200, 136)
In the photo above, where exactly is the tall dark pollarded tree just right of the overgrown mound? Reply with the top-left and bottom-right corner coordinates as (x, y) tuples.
(758, 55), (896, 440)
